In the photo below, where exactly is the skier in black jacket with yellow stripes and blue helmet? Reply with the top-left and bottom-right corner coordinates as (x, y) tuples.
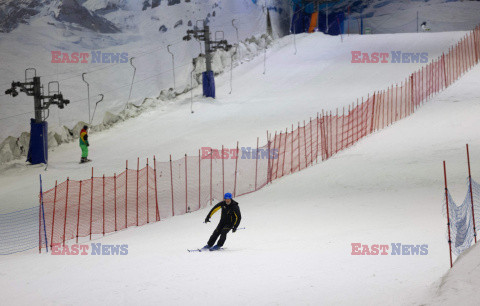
(203, 193), (242, 251)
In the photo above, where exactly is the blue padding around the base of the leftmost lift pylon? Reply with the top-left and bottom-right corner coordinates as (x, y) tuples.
(27, 119), (48, 165)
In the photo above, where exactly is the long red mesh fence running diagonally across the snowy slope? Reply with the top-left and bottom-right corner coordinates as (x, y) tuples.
(39, 27), (480, 249)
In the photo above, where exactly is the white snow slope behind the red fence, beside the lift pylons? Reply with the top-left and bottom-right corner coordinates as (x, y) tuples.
(0, 32), (465, 213)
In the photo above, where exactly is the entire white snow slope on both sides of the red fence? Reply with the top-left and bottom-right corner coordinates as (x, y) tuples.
(0, 29), (480, 305)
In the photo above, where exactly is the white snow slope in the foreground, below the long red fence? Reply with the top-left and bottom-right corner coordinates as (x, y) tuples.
(0, 53), (480, 305)
